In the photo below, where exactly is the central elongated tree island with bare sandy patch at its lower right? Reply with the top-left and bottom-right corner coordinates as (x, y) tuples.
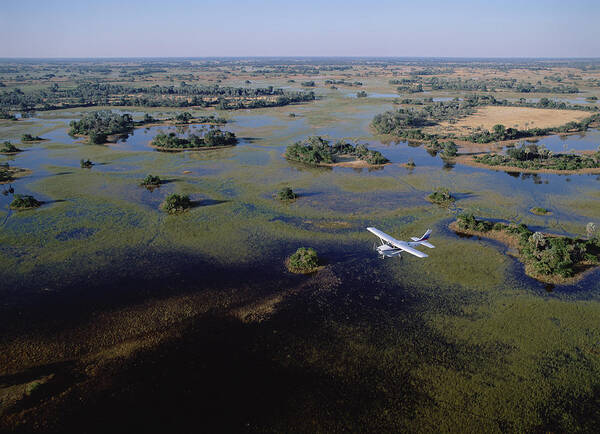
(285, 136), (389, 165)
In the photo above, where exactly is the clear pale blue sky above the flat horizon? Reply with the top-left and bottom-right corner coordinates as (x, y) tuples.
(0, 0), (600, 57)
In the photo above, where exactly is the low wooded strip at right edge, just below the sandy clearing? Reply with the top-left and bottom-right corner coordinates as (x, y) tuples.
(473, 143), (600, 170)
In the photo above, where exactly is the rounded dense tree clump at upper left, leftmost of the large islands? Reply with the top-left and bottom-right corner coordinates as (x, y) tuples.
(69, 110), (134, 145)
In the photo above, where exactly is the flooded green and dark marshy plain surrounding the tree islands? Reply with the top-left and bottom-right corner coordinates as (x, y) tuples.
(0, 59), (600, 432)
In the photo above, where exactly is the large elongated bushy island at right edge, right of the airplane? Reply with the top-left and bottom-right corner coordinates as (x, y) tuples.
(456, 214), (600, 280)
